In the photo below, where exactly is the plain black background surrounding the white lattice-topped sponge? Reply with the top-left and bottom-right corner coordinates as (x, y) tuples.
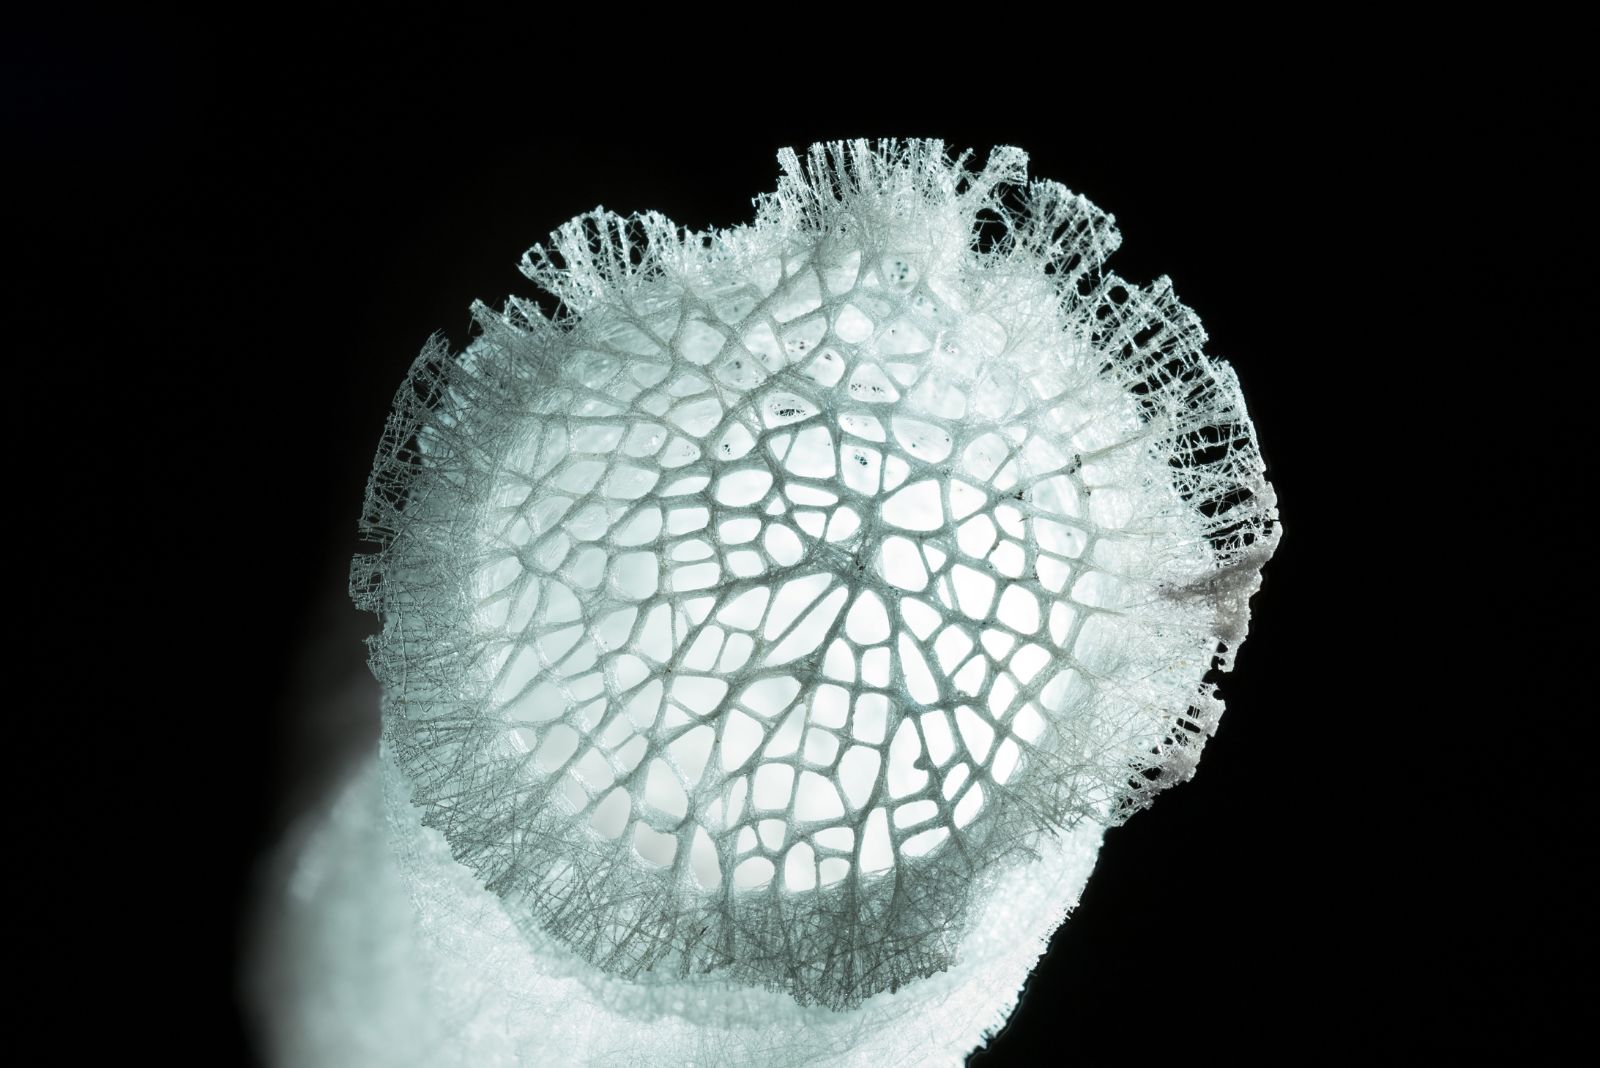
(18, 21), (1594, 1068)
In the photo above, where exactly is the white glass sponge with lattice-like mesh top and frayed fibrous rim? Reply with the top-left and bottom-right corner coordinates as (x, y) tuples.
(331, 141), (1277, 1065)
